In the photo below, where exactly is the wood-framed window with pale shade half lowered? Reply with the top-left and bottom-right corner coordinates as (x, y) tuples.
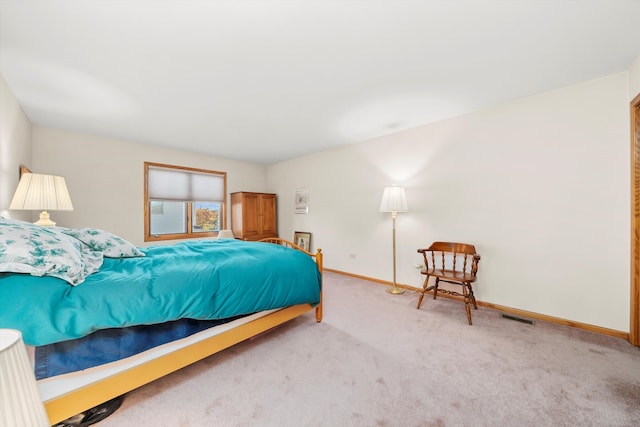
(144, 162), (227, 242)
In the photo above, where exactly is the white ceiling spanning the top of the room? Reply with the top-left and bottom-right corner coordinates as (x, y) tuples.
(0, 0), (640, 164)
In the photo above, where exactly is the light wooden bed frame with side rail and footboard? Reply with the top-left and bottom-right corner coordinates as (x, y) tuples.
(44, 238), (322, 425)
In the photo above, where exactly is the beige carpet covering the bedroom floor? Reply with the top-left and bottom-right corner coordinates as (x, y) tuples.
(96, 273), (640, 427)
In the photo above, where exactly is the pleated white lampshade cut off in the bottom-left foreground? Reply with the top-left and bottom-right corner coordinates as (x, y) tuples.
(0, 329), (51, 427)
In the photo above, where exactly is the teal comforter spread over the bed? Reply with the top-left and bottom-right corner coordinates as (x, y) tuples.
(0, 239), (321, 346)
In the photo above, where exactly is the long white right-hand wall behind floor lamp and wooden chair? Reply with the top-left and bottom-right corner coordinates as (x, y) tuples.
(268, 72), (630, 331)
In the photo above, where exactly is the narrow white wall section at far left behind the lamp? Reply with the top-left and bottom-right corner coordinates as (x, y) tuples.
(0, 74), (32, 221)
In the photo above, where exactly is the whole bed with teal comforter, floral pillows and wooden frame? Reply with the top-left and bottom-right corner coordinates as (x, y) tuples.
(0, 218), (322, 424)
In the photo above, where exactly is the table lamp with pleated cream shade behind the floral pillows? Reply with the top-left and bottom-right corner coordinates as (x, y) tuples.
(9, 173), (73, 226)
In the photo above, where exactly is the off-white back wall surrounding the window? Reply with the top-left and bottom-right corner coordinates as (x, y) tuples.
(33, 126), (266, 246)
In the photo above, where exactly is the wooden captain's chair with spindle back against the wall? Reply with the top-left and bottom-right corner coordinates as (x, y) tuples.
(416, 242), (480, 325)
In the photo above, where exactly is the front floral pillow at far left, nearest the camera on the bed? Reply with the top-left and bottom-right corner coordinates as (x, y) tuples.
(0, 218), (103, 286)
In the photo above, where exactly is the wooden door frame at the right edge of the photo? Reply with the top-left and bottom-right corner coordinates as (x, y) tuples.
(629, 94), (640, 346)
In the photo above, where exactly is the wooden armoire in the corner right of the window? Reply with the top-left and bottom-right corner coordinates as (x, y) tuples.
(231, 191), (278, 240)
